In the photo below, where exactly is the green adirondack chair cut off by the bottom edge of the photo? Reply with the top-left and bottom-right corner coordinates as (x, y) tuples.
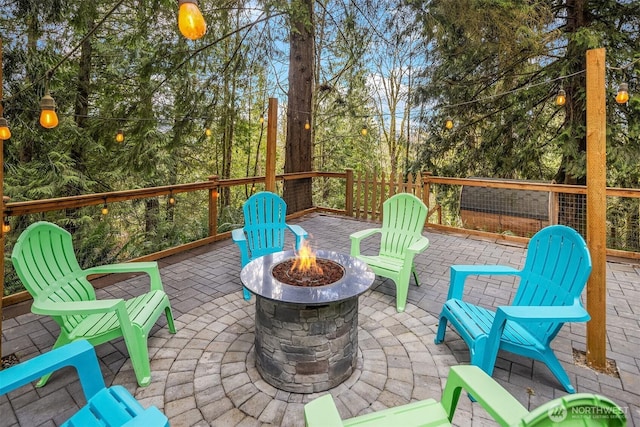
(304, 365), (626, 427)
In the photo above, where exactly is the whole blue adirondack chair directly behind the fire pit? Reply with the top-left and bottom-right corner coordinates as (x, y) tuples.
(231, 191), (307, 300)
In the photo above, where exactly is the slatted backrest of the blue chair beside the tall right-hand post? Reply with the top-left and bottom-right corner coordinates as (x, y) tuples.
(513, 225), (591, 344)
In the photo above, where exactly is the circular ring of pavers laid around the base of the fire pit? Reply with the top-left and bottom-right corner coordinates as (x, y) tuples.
(136, 291), (444, 426)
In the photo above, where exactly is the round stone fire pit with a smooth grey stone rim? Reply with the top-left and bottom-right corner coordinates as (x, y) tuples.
(240, 250), (375, 393)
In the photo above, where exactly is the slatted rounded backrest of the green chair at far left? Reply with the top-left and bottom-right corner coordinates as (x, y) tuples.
(11, 221), (96, 331)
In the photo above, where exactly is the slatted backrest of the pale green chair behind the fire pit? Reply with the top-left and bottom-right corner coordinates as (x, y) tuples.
(380, 193), (427, 259)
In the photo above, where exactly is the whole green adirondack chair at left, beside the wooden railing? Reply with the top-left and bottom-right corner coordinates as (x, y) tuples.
(11, 221), (176, 387)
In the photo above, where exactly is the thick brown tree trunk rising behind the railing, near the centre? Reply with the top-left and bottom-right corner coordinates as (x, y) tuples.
(283, 0), (314, 213)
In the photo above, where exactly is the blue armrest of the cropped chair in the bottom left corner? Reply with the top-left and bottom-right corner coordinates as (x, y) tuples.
(0, 340), (105, 400)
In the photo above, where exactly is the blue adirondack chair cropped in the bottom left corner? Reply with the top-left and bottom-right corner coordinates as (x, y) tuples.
(0, 340), (169, 427)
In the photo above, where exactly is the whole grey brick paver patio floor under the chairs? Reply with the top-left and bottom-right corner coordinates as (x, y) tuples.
(0, 214), (640, 427)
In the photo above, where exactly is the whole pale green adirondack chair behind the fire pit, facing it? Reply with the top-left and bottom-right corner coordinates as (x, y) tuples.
(349, 193), (429, 312)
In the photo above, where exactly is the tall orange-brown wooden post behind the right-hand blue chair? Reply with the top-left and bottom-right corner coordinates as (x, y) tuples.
(587, 48), (607, 369)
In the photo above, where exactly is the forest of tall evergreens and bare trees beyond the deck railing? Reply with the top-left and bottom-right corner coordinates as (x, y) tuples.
(0, 0), (640, 292)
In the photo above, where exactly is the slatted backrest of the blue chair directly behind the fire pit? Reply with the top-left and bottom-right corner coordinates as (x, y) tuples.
(243, 191), (287, 259)
